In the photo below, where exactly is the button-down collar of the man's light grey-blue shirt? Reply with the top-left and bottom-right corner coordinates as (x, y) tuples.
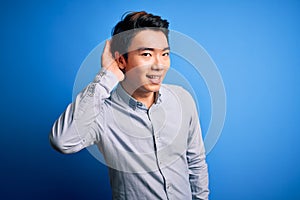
(116, 84), (161, 110)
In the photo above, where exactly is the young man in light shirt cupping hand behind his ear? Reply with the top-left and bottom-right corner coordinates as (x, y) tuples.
(50, 12), (209, 200)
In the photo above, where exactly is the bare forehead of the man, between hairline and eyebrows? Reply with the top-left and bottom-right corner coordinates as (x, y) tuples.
(128, 30), (169, 51)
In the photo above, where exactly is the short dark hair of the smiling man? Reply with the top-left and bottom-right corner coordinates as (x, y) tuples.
(111, 11), (169, 59)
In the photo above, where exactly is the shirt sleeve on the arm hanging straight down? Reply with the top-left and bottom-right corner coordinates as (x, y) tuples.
(187, 94), (209, 200)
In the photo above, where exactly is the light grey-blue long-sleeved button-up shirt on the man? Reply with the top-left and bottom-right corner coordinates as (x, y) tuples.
(50, 71), (209, 200)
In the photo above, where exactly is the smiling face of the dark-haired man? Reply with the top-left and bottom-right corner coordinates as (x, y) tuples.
(122, 30), (170, 93)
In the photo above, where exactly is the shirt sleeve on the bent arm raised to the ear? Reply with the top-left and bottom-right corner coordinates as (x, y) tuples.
(49, 69), (118, 154)
